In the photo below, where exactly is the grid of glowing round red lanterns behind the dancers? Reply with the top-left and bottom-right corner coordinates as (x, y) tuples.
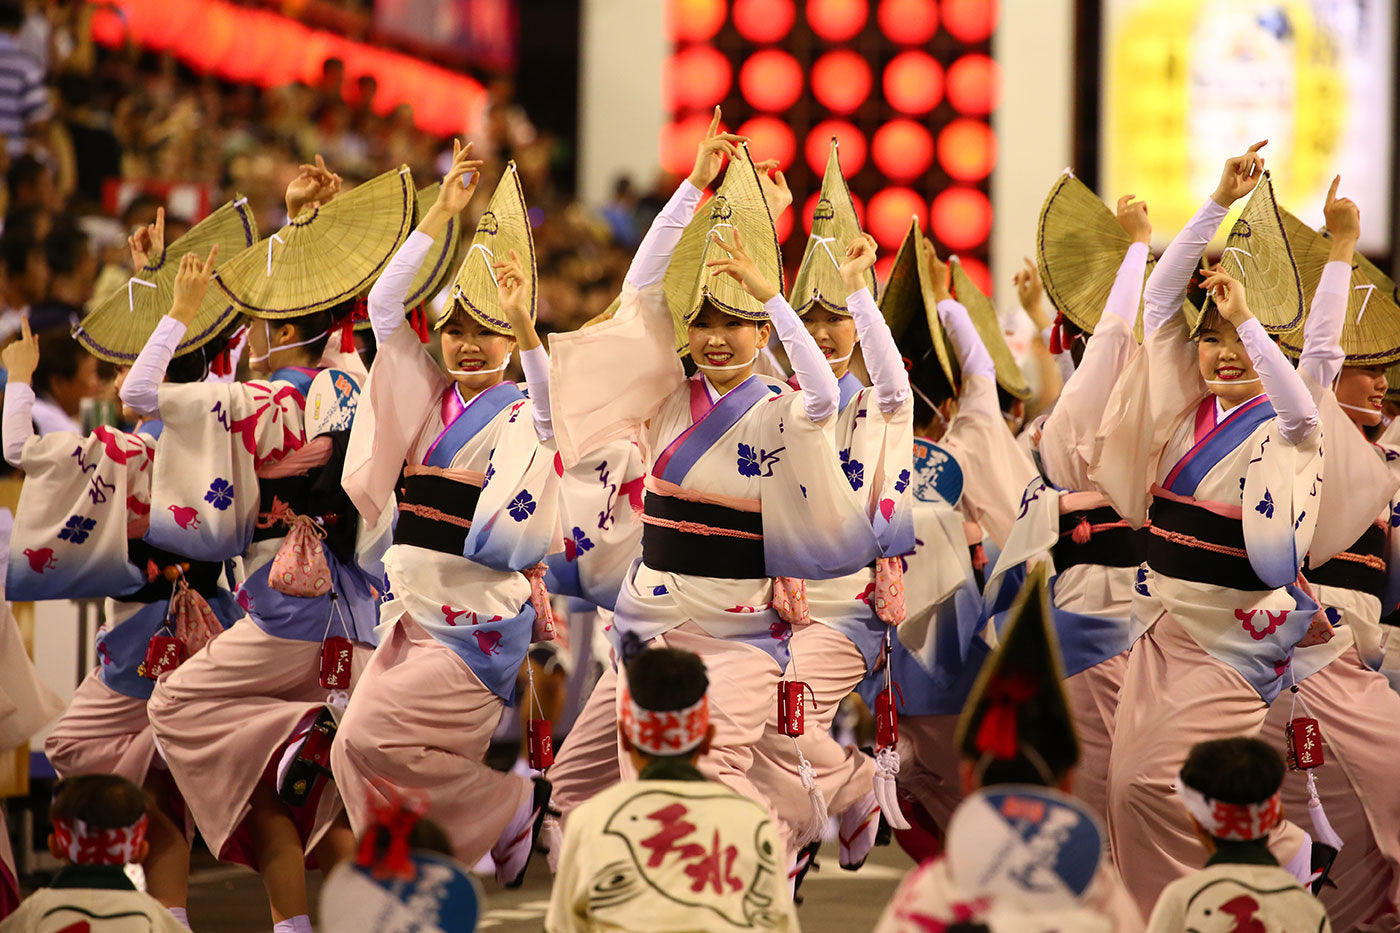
(661, 0), (1000, 291)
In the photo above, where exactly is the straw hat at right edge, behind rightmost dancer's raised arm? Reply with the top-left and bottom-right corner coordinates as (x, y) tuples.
(1278, 210), (1400, 366)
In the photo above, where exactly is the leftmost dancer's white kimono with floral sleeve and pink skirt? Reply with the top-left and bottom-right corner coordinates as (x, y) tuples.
(6, 387), (244, 795)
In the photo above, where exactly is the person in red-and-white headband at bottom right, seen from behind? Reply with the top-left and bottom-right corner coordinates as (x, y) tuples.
(1148, 737), (1331, 933)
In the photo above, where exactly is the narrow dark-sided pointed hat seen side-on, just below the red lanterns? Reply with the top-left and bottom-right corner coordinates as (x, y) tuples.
(879, 217), (959, 395)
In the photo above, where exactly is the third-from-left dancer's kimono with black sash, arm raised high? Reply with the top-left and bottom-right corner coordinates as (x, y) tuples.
(330, 226), (560, 864)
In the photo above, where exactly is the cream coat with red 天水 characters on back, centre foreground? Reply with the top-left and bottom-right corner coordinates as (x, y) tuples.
(545, 772), (798, 933)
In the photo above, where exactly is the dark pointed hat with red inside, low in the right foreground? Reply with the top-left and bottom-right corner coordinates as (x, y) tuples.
(953, 560), (1079, 766)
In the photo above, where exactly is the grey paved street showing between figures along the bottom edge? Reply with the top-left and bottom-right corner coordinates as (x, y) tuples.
(180, 842), (913, 933)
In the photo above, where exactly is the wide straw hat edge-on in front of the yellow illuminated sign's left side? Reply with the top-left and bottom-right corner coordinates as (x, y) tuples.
(1036, 168), (1141, 333)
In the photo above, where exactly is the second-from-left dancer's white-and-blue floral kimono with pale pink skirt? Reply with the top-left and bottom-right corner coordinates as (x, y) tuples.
(122, 318), (378, 864)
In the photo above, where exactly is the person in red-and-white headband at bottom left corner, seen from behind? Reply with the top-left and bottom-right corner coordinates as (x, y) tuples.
(0, 775), (185, 933)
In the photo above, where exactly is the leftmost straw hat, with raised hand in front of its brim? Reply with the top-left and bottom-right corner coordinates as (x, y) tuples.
(73, 198), (258, 366)
